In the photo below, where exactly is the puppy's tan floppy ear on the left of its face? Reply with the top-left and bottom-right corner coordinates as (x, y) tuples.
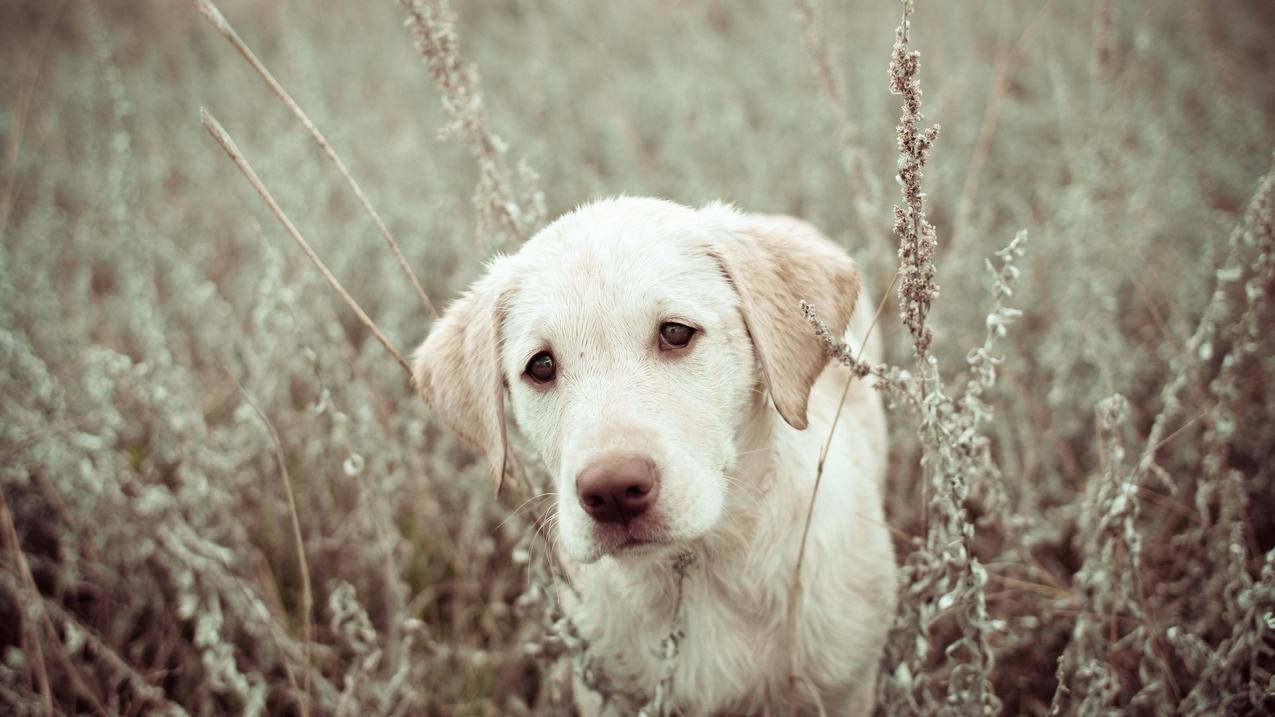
(412, 264), (520, 494)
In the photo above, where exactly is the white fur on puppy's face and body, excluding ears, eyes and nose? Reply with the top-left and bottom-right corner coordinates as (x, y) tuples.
(417, 199), (895, 714)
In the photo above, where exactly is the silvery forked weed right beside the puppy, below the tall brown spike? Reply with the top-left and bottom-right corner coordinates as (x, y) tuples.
(802, 227), (1026, 714)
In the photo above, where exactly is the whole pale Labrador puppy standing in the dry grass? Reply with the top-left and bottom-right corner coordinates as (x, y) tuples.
(413, 198), (895, 714)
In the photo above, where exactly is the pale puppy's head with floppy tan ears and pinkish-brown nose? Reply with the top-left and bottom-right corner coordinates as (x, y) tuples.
(413, 199), (859, 561)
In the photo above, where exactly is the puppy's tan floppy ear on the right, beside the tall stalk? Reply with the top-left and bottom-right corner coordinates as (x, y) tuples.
(710, 207), (859, 430)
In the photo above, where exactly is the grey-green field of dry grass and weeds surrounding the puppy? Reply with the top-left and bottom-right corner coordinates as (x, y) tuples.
(0, 0), (1275, 714)
